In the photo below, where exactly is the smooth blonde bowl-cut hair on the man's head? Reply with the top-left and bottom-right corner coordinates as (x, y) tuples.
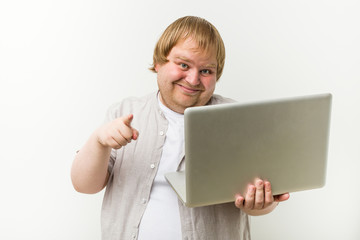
(150, 16), (225, 80)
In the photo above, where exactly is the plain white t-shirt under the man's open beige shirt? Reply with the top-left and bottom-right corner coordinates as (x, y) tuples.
(138, 95), (184, 240)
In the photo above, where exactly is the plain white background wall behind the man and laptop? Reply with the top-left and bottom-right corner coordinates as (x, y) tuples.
(0, 0), (360, 240)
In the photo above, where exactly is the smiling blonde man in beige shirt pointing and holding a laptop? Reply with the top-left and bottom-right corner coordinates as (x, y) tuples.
(71, 17), (289, 240)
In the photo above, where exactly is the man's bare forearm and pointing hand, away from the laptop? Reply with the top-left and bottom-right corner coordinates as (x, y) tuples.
(71, 114), (139, 193)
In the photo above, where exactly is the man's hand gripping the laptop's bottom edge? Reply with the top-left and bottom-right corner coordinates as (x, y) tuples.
(235, 179), (290, 216)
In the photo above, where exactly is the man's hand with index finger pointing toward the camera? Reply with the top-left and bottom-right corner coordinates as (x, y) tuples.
(96, 114), (139, 149)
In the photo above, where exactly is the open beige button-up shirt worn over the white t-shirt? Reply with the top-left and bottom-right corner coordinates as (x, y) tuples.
(101, 93), (250, 240)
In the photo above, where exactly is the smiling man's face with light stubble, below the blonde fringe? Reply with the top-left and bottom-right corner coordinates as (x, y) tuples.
(155, 38), (217, 113)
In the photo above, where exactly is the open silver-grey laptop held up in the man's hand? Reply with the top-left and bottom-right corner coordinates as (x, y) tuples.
(165, 93), (332, 207)
